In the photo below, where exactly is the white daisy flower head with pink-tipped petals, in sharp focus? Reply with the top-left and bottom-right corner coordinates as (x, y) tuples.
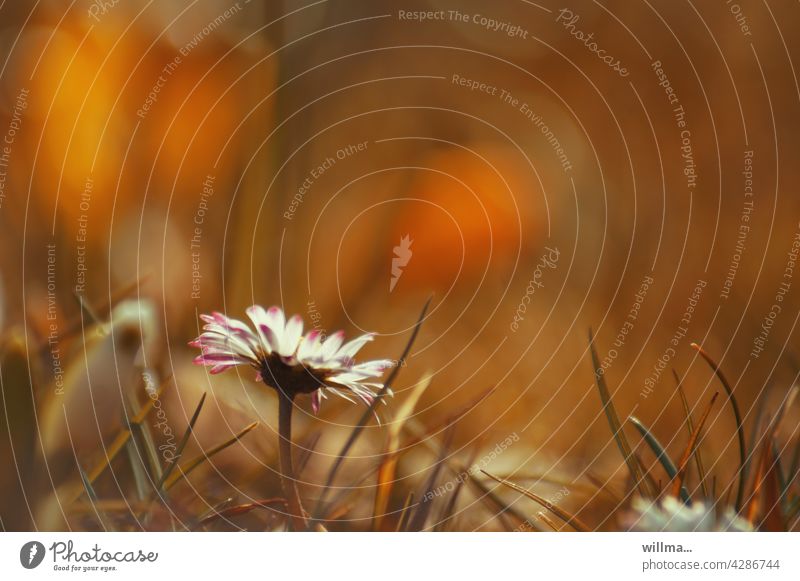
(189, 305), (393, 413)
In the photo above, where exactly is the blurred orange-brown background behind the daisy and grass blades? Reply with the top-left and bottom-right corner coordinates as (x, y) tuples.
(0, 0), (800, 530)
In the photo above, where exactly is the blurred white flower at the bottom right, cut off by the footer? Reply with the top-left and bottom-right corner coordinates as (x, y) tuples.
(624, 496), (753, 532)
